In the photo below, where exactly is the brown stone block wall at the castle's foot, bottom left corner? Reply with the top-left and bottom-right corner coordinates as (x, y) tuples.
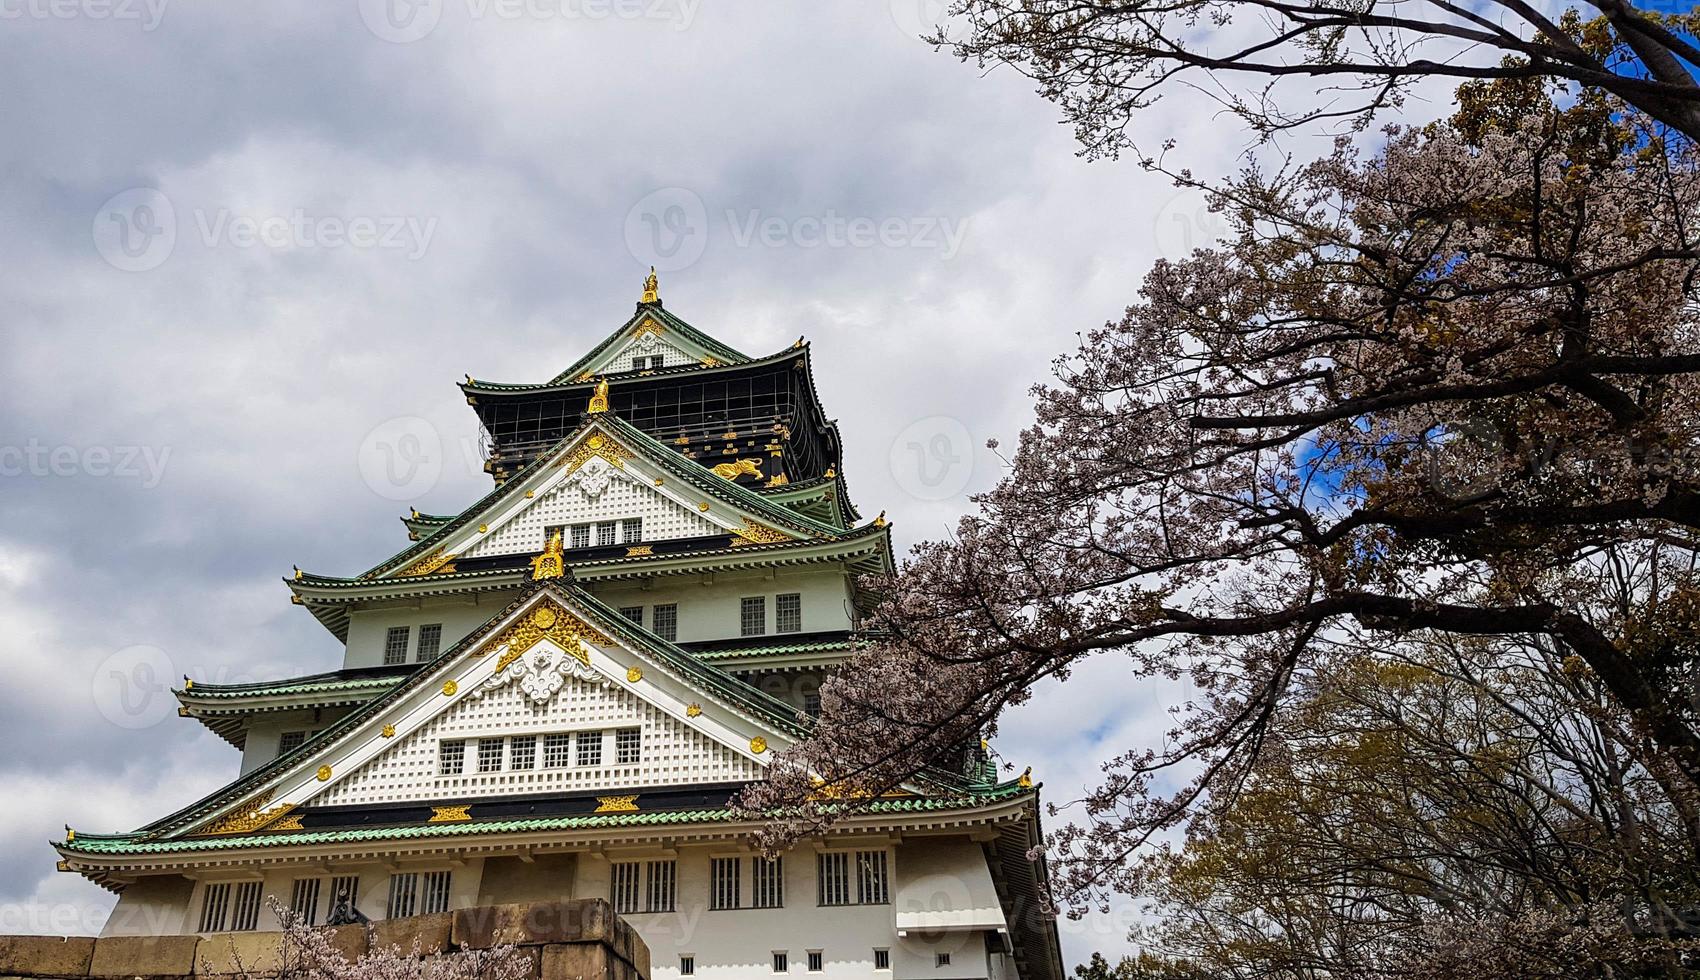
(0, 898), (649, 980)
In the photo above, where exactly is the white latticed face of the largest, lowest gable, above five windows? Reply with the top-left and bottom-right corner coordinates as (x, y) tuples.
(313, 677), (762, 806)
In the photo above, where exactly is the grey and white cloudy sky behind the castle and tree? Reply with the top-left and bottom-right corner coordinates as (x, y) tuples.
(0, 0), (1448, 960)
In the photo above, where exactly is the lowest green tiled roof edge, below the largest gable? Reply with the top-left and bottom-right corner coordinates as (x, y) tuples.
(54, 783), (1039, 854)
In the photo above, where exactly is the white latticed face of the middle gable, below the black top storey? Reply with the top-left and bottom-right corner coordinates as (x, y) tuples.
(464, 456), (726, 558)
